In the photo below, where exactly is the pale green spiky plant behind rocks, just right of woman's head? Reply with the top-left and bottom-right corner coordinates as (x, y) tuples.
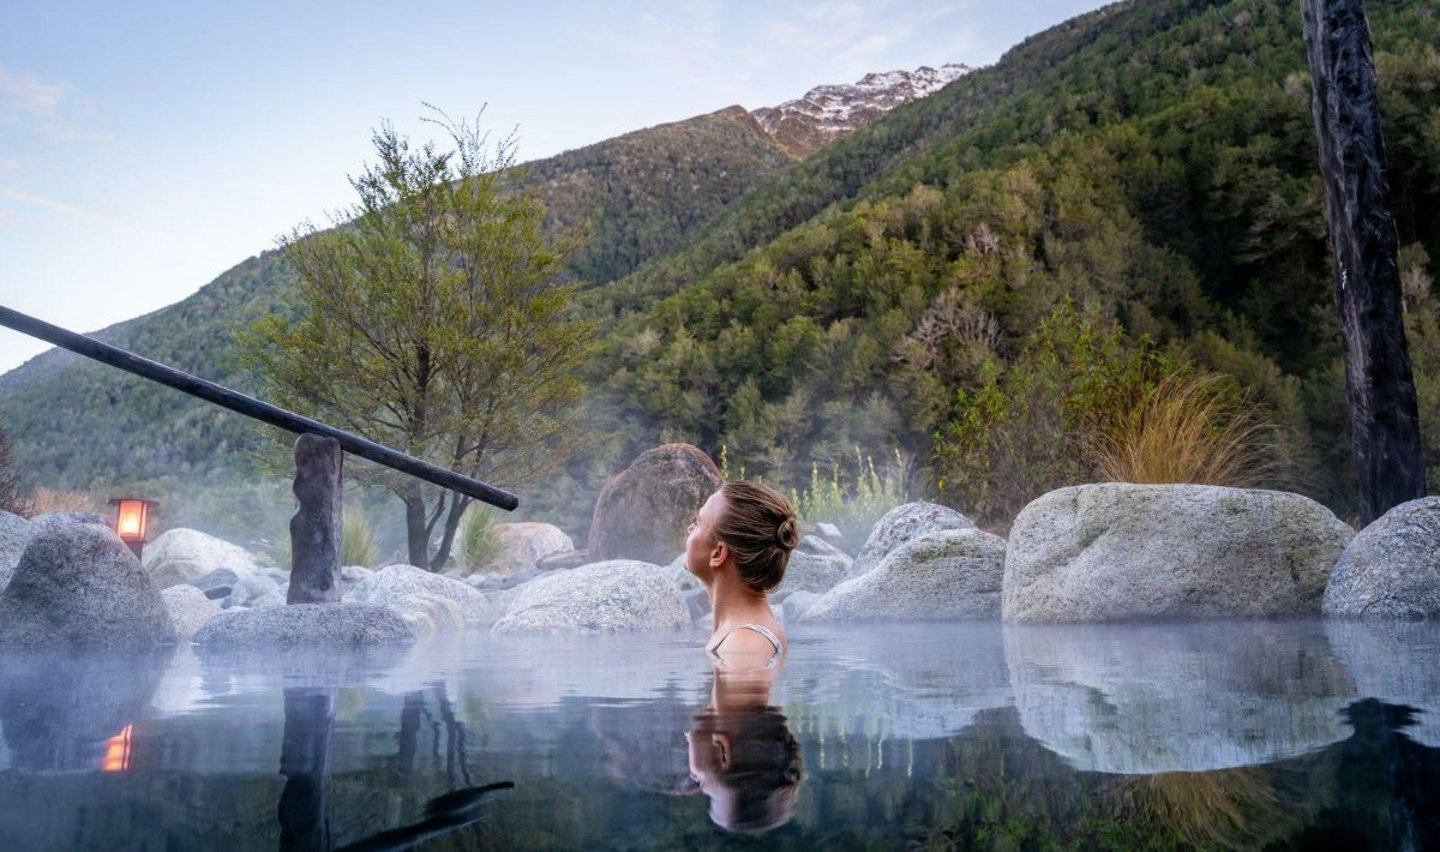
(791, 448), (910, 550)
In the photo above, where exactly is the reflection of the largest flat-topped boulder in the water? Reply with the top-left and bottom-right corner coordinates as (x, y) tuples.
(1005, 622), (1355, 774)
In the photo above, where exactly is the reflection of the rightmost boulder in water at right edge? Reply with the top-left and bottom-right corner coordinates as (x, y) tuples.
(1325, 620), (1440, 748)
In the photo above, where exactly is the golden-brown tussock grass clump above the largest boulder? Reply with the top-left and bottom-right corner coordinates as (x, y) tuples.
(1087, 371), (1287, 488)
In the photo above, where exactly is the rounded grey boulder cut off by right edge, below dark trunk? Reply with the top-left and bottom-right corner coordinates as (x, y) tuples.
(1322, 497), (1440, 619)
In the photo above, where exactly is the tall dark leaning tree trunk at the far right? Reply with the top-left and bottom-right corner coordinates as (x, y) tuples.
(1300, 0), (1426, 524)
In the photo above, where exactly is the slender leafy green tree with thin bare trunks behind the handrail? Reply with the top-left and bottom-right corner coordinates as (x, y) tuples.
(240, 114), (595, 570)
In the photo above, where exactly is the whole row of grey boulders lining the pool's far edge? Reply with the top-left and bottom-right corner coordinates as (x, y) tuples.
(0, 445), (1440, 648)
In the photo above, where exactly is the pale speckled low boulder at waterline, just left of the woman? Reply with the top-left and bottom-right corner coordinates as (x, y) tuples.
(492, 560), (691, 633)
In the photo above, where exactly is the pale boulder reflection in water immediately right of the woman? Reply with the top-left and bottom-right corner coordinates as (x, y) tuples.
(780, 622), (1011, 740)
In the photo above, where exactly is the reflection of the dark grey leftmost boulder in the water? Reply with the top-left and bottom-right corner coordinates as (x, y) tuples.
(0, 648), (173, 771)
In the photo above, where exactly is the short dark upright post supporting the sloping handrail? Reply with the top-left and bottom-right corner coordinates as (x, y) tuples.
(285, 433), (344, 603)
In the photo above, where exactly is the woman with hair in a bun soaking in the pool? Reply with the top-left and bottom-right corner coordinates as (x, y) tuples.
(685, 481), (801, 669)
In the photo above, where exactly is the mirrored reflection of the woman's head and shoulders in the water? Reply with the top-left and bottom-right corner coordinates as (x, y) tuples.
(685, 668), (804, 832)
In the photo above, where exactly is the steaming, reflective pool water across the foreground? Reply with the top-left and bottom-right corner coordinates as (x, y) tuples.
(0, 622), (1440, 851)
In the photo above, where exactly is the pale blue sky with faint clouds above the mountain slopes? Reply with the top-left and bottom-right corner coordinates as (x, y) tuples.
(0, 0), (1106, 373)
